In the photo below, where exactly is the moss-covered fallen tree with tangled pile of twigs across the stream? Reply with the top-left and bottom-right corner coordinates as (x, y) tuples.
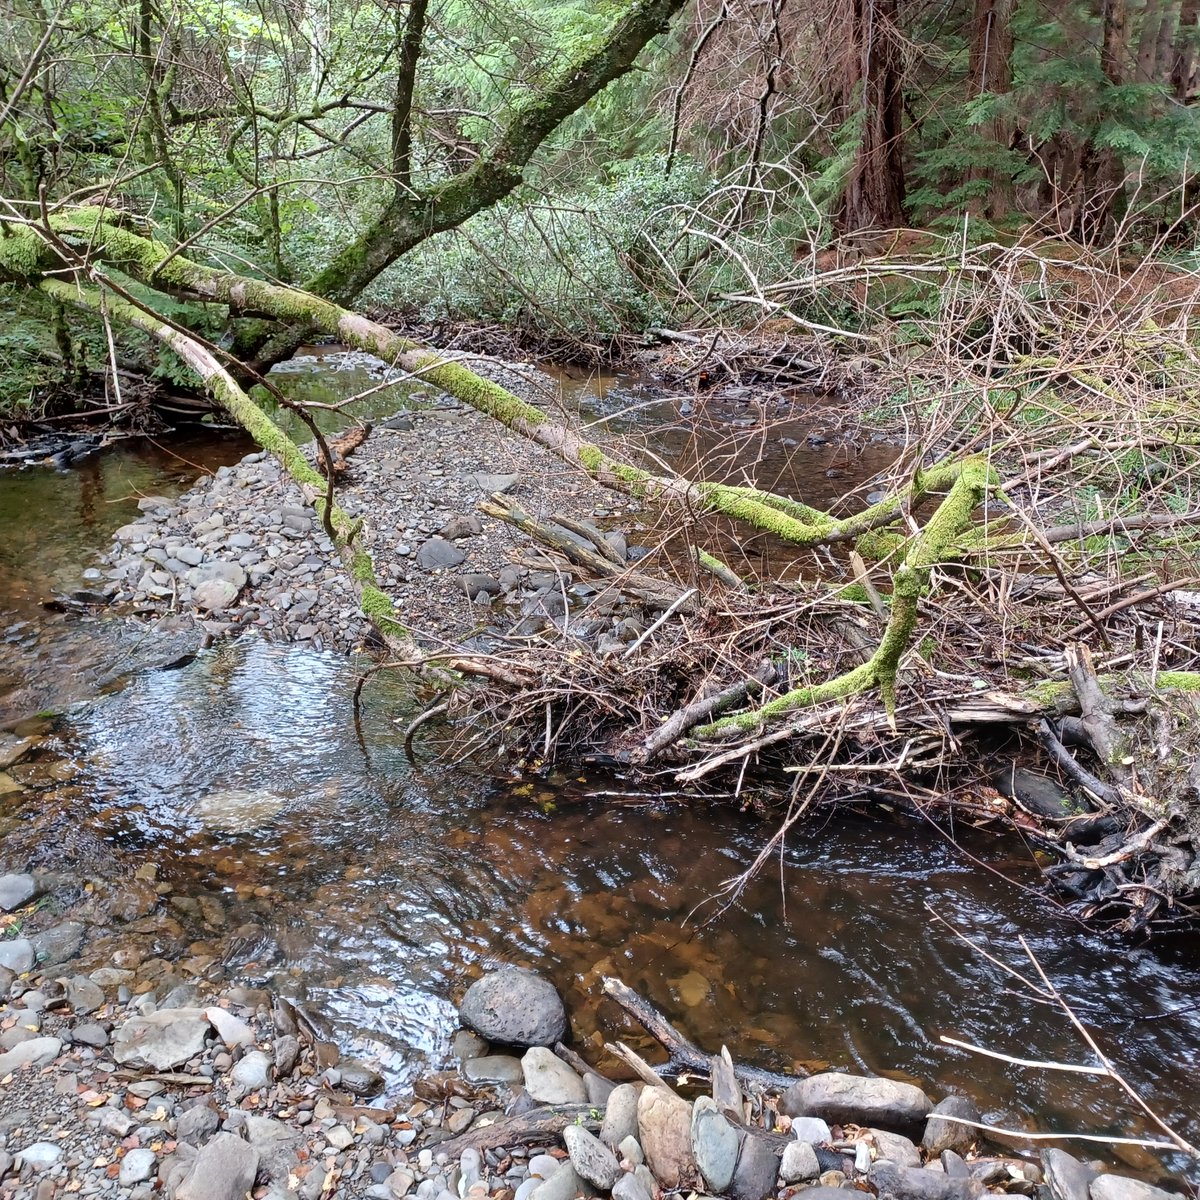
(0, 208), (1200, 925)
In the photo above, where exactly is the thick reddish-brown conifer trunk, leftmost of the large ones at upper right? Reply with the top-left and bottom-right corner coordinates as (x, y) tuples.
(840, 0), (905, 233)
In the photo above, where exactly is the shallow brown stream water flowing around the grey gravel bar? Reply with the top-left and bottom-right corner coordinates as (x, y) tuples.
(0, 360), (1200, 1176)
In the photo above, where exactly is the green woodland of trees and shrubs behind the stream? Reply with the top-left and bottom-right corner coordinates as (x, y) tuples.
(0, 0), (1200, 410)
